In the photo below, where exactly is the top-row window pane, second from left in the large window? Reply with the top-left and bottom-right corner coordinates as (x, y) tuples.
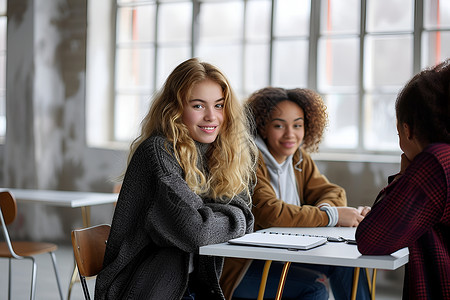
(158, 2), (192, 43)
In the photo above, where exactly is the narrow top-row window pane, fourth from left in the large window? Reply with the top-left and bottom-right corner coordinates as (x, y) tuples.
(245, 0), (271, 41)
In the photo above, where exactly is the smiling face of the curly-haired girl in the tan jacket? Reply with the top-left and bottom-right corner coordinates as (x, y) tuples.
(263, 100), (305, 163)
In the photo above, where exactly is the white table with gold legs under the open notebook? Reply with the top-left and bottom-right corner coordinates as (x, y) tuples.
(200, 227), (409, 299)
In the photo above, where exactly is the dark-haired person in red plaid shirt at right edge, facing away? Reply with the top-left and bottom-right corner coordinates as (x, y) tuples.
(356, 59), (450, 299)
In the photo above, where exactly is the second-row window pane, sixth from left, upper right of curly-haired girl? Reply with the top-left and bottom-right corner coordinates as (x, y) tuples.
(317, 38), (359, 92)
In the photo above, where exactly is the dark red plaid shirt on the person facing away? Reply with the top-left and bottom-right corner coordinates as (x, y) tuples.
(356, 143), (450, 299)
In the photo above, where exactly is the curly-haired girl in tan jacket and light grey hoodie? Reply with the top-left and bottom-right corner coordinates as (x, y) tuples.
(221, 87), (370, 300)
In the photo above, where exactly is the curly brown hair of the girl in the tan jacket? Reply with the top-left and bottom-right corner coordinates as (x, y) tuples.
(246, 87), (328, 152)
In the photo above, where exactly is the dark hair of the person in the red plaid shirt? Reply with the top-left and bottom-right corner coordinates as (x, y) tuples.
(395, 59), (450, 144)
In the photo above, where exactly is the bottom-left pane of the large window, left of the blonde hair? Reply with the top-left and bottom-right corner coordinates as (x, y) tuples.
(114, 95), (150, 142)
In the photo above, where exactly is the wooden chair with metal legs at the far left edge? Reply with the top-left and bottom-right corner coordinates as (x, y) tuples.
(0, 191), (63, 300)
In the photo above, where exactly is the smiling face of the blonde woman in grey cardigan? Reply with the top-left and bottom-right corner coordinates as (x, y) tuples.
(183, 79), (225, 144)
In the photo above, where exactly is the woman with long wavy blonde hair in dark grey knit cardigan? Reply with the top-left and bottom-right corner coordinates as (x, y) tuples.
(95, 58), (257, 300)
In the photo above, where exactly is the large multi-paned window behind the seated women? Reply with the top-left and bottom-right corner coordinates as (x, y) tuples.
(86, 0), (450, 158)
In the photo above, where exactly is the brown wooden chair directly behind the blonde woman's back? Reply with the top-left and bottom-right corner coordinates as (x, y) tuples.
(72, 224), (111, 300)
